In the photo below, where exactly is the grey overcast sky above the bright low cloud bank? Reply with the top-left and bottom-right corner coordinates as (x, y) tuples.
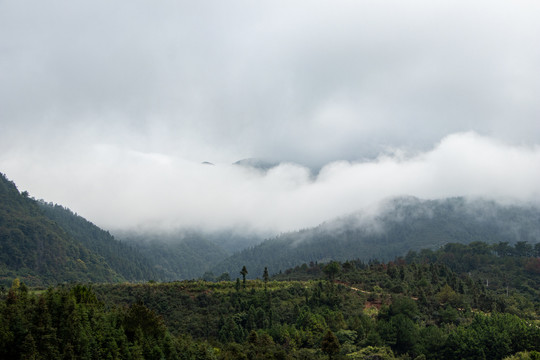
(0, 0), (540, 166)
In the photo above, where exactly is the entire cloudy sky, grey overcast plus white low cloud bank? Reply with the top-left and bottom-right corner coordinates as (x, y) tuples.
(0, 0), (540, 235)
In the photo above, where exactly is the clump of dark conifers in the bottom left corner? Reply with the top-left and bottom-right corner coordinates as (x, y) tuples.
(0, 285), (182, 359)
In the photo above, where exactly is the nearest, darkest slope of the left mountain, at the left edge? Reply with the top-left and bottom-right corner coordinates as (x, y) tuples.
(0, 174), (124, 285)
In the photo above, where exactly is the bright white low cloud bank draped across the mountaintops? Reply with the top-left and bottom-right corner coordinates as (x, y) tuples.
(0, 133), (540, 234)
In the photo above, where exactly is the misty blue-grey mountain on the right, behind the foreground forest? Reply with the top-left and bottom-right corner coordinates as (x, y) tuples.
(212, 197), (540, 278)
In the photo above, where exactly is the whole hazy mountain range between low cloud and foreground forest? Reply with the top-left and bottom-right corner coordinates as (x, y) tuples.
(0, 172), (540, 285)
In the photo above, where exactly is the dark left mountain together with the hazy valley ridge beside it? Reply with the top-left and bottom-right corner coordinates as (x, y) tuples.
(0, 174), (232, 286)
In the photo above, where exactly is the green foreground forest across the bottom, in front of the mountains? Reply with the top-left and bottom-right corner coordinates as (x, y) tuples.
(0, 242), (540, 359)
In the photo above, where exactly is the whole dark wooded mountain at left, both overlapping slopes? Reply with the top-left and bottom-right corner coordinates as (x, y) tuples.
(0, 174), (162, 285)
